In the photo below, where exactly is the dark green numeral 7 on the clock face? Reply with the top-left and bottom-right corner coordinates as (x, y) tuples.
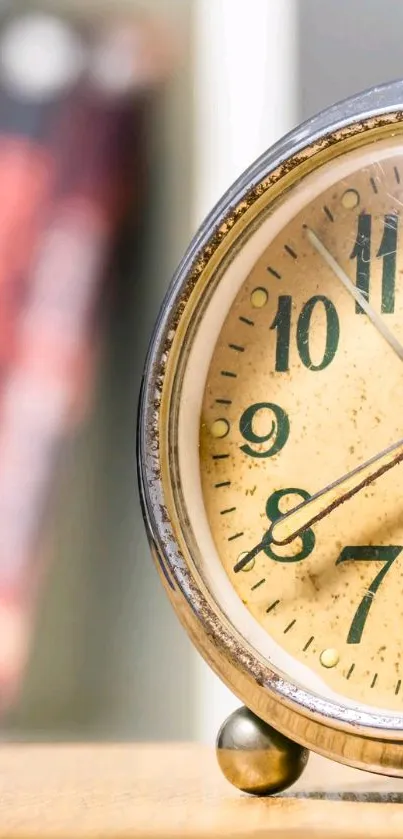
(336, 545), (402, 644)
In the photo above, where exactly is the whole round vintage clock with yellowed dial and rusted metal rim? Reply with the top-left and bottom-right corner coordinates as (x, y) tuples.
(139, 82), (403, 796)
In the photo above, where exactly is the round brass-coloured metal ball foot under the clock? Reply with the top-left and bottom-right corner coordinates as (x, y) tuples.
(216, 707), (309, 795)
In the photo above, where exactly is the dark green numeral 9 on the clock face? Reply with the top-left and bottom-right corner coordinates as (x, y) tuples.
(239, 402), (290, 457)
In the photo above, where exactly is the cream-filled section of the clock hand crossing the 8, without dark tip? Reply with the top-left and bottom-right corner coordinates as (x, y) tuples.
(270, 438), (403, 545)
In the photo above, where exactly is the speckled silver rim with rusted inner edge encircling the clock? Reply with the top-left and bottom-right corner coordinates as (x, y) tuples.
(138, 81), (403, 771)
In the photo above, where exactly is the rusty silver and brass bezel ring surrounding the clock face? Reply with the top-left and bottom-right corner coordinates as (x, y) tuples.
(138, 81), (403, 777)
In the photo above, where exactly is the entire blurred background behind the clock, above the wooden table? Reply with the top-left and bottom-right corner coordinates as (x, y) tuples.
(0, 0), (403, 741)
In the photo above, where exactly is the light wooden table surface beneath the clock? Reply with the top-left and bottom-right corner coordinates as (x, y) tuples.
(0, 745), (403, 839)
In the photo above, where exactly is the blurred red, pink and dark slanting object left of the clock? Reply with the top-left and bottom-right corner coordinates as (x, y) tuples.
(0, 7), (171, 711)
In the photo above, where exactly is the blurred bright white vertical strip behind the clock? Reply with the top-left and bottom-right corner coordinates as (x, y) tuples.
(193, 0), (297, 742)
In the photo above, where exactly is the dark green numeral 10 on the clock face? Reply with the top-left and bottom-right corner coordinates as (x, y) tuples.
(270, 294), (340, 373)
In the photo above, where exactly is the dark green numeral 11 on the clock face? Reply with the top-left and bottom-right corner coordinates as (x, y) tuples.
(350, 213), (399, 314)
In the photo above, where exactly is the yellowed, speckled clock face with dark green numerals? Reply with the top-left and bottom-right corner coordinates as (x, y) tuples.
(196, 136), (403, 712)
